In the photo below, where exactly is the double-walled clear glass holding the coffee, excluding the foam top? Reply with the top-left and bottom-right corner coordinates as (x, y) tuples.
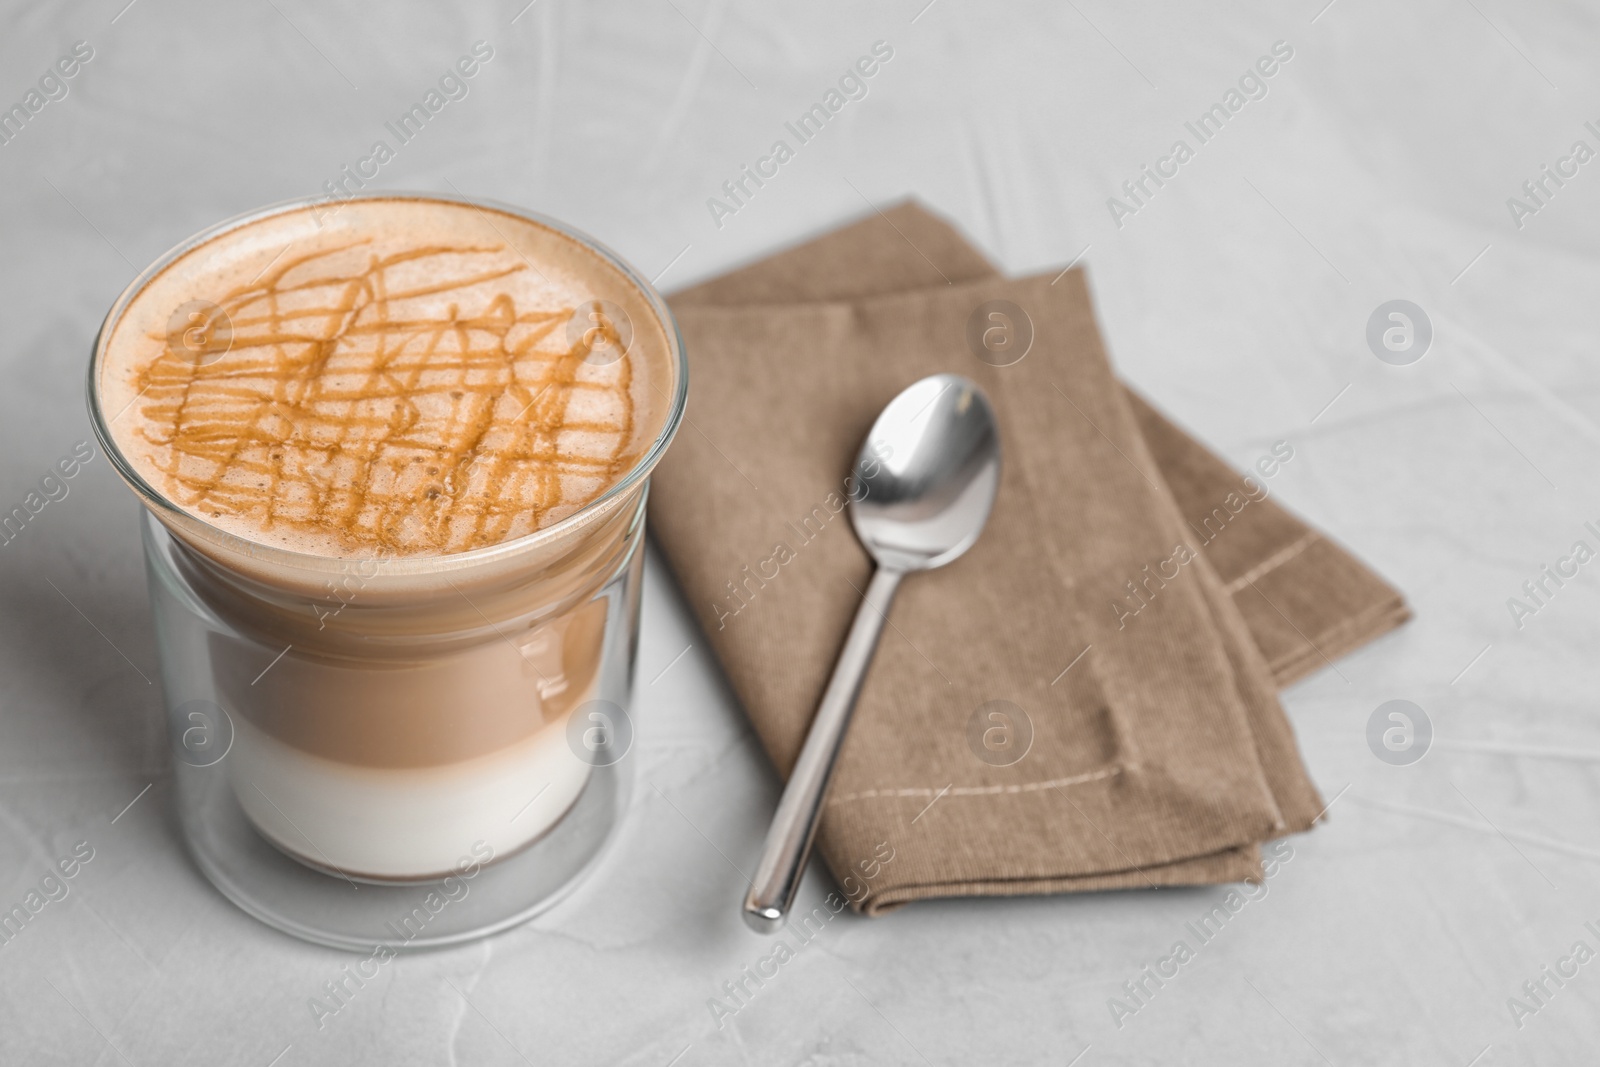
(90, 194), (688, 950)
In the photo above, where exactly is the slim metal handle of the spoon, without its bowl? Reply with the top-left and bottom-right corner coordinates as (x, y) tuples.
(744, 566), (902, 934)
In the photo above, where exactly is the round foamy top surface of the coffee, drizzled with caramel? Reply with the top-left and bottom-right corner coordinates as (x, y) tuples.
(94, 197), (675, 557)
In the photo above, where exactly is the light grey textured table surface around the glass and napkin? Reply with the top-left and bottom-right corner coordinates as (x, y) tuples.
(0, 0), (1600, 1067)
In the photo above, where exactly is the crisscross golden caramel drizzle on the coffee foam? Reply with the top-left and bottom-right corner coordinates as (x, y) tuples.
(134, 242), (637, 553)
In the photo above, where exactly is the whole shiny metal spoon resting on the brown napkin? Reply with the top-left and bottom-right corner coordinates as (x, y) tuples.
(744, 374), (1000, 934)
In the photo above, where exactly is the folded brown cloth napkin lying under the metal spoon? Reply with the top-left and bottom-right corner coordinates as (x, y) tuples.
(651, 205), (1405, 913)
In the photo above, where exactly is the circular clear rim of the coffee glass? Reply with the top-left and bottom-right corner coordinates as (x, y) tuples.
(86, 190), (690, 574)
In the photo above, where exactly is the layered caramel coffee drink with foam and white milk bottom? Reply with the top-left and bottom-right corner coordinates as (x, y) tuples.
(91, 195), (683, 880)
